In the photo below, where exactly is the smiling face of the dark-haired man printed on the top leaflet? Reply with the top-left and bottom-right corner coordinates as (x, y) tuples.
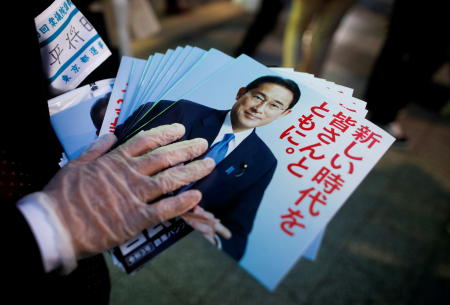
(231, 83), (294, 132)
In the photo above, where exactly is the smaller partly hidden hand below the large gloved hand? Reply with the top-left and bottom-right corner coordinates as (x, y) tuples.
(181, 205), (231, 245)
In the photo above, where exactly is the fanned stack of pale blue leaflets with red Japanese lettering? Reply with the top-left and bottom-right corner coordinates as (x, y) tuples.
(49, 46), (394, 290)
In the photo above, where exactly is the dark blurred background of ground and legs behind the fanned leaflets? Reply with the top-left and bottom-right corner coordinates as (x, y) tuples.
(90, 0), (450, 305)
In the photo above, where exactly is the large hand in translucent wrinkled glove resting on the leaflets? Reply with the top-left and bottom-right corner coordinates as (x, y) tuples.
(35, 124), (214, 270)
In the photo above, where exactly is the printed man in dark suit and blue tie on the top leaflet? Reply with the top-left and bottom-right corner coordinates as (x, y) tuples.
(116, 75), (300, 261)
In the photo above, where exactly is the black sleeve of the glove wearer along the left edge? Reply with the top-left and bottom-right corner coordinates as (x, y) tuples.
(0, 0), (56, 280)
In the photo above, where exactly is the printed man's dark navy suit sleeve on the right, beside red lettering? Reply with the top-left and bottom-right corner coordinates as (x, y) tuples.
(220, 162), (276, 261)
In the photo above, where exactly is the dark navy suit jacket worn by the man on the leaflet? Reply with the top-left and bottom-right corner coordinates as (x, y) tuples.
(116, 100), (277, 260)
